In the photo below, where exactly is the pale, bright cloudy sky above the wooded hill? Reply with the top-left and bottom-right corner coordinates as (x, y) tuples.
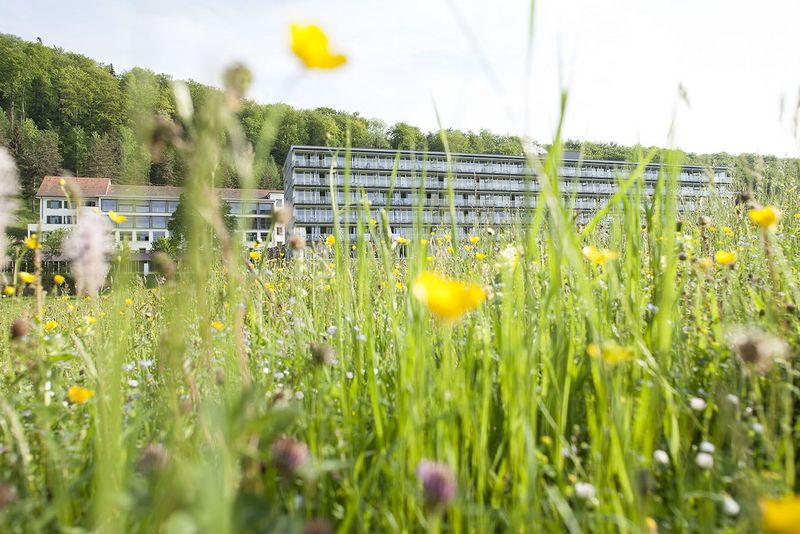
(0, 0), (800, 157)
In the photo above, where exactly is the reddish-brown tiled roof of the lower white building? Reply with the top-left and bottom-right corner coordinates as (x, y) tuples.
(36, 176), (283, 200)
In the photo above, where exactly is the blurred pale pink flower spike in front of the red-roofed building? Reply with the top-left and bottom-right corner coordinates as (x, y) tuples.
(64, 209), (114, 297)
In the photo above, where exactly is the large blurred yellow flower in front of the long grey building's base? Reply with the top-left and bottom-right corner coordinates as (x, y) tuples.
(411, 271), (486, 323)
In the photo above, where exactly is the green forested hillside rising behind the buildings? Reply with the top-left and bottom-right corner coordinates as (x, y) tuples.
(0, 34), (798, 201)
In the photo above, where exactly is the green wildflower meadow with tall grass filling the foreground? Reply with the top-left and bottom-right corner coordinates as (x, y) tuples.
(0, 22), (800, 534)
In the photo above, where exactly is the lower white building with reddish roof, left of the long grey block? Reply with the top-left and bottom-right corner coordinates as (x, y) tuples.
(28, 176), (285, 273)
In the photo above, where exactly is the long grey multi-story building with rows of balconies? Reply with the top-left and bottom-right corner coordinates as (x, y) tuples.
(283, 146), (732, 240)
